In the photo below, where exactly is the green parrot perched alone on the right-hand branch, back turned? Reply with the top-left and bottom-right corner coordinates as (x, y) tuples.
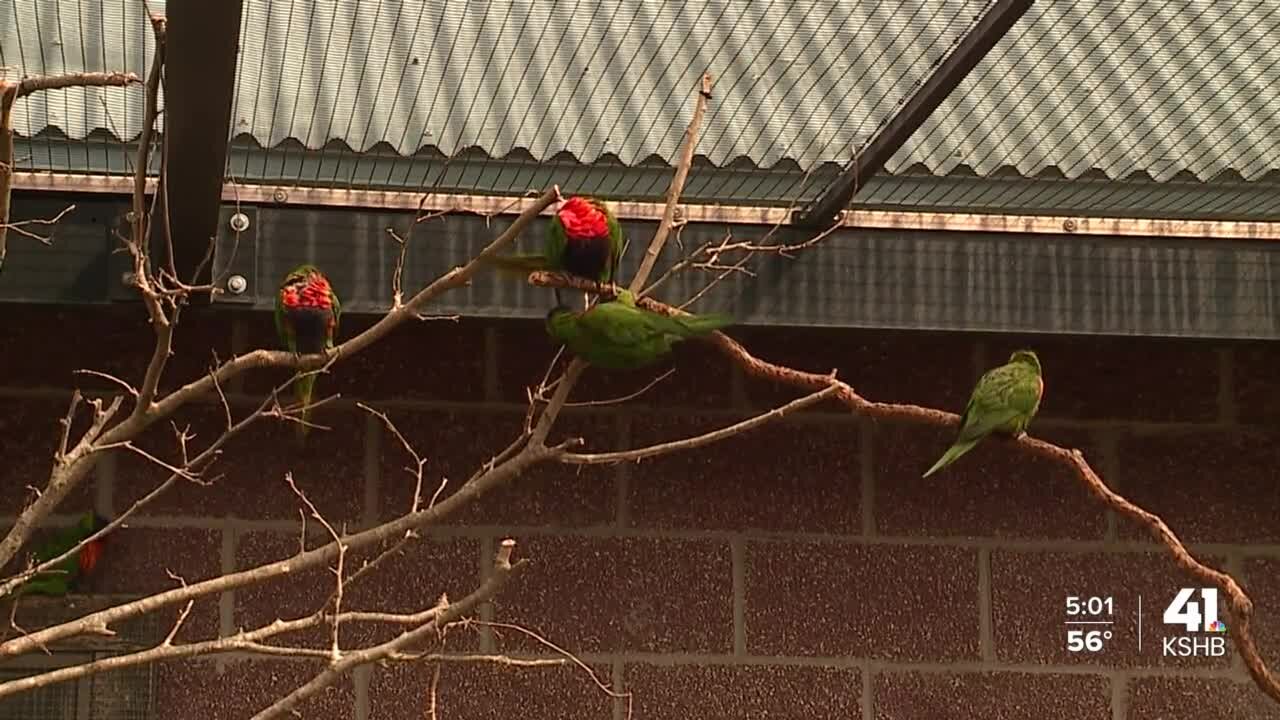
(924, 350), (1044, 478)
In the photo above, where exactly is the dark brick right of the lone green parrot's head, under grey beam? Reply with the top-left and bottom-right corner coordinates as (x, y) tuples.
(977, 334), (1219, 423)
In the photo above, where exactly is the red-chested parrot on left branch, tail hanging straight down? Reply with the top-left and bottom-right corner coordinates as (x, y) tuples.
(275, 265), (342, 442)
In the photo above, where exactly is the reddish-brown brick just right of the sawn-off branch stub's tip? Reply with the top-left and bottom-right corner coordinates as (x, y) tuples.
(494, 537), (733, 652)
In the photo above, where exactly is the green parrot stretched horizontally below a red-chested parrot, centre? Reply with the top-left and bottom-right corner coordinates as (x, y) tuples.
(547, 290), (733, 370)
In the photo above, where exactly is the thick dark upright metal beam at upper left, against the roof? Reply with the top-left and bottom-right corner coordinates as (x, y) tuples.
(164, 0), (243, 282)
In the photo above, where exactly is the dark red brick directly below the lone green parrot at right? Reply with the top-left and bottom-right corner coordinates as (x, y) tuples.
(872, 423), (1106, 538)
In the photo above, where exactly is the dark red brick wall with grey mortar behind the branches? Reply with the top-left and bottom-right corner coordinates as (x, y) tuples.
(0, 306), (1280, 720)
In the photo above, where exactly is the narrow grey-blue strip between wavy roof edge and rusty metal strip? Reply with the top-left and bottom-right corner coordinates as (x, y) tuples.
(14, 132), (1280, 222)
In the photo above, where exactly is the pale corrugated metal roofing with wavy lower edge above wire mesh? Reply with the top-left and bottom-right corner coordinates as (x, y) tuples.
(0, 0), (1280, 194)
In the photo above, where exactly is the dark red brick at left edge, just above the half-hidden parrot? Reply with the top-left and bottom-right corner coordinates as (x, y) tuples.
(0, 397), (95, 515)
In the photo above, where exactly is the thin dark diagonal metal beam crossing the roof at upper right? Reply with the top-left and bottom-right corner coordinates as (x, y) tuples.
(791, 0), (1034, 229)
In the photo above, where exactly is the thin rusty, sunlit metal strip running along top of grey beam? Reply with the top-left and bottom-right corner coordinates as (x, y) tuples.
(13, 173), (1280, 241)
